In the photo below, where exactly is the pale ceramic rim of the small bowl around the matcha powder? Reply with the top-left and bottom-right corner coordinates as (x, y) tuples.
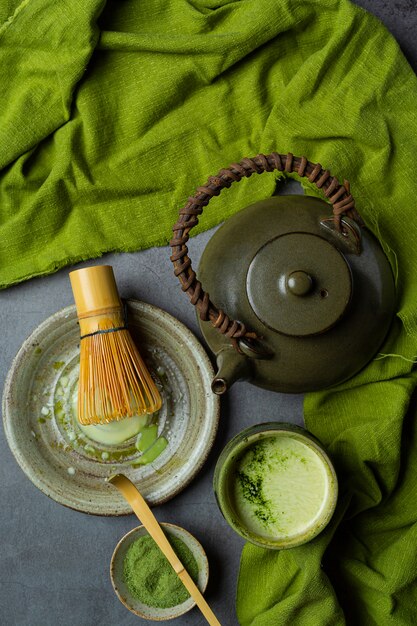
(110, 523), (209, 621)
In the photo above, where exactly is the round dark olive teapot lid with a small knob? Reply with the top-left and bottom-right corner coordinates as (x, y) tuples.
(246, 232), (352, 337)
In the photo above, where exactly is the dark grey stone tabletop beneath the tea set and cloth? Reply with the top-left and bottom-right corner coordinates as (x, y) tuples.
(0, 0), (417, 626)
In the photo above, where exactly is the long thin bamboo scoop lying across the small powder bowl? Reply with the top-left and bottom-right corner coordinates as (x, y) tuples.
(108, 474), (221, 626)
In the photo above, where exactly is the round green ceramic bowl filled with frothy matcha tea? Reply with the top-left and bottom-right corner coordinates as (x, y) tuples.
(214, 422), (338, 549)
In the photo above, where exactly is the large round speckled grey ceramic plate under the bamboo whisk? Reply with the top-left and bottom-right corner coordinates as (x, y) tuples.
(3, 300), (219, 515)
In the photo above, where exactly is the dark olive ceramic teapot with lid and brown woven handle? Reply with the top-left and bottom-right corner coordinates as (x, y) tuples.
(171, 153), (395, 394)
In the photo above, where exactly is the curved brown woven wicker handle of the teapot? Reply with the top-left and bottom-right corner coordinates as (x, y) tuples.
(170, 152), (360, 349)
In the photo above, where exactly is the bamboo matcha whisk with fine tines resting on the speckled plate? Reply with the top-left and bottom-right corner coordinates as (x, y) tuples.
(70, 265), (162, 424)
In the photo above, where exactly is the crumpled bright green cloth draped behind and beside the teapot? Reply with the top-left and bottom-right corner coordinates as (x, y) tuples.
(0, 0), (417, 626)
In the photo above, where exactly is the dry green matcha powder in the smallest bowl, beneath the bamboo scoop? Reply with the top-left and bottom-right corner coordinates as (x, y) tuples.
(123, 535), (198, 609)
